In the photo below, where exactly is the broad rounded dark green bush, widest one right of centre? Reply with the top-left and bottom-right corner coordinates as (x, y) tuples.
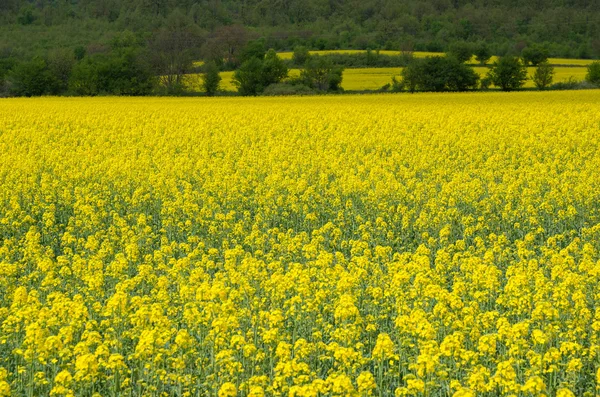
(402, 57), (479, 92)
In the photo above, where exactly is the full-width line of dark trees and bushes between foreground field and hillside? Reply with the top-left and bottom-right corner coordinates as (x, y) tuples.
(0, 12), (597, 96)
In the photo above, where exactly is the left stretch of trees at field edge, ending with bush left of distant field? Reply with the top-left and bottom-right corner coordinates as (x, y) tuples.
(0, 14), (343, 97)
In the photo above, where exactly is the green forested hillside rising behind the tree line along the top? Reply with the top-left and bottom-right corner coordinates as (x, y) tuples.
(0, 0), (600, 58)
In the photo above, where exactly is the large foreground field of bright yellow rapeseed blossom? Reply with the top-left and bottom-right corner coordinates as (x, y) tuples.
(0, 91), (600, 397)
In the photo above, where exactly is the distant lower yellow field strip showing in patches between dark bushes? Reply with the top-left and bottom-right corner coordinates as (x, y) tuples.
(188, 66), (587, 91)
